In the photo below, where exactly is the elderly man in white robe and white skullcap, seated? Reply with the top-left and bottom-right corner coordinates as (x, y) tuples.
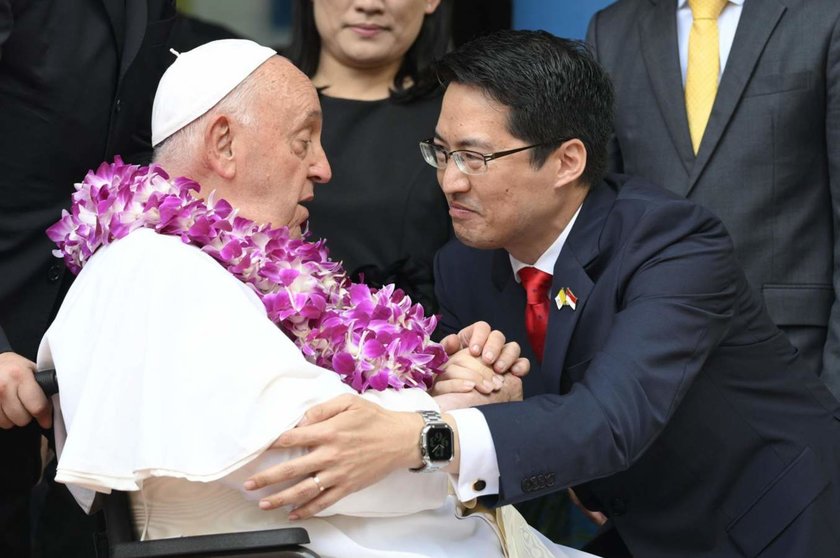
(38, 41), (596, 557)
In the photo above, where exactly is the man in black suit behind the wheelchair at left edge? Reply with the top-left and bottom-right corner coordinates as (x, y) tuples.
(0, 0), (175, 558)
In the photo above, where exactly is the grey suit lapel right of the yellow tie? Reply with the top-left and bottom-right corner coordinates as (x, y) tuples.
(684, 0), (786, 194)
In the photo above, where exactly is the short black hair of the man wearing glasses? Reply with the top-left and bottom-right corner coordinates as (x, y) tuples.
(434, 30), (613, 186)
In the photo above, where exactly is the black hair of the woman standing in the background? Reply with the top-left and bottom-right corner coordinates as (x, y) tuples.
(283, 0), (451, 102)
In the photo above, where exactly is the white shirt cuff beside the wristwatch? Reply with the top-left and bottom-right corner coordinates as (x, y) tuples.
(448, 409), (499, 502)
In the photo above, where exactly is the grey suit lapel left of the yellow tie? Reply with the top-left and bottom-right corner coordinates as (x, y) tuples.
(639, 0), (692, 182)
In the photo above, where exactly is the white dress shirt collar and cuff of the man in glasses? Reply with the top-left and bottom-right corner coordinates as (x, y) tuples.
(449, 206), (582, 502)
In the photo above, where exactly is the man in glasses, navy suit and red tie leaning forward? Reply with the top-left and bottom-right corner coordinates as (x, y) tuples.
(249, 31), (840, 558)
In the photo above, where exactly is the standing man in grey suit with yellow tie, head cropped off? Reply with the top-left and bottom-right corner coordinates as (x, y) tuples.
(588, 0), (840, 402)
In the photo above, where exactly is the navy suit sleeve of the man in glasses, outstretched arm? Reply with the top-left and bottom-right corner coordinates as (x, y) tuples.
(479, 200), (743, 504)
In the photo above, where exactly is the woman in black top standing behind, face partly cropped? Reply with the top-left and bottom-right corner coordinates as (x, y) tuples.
(286, 0), (451, 312)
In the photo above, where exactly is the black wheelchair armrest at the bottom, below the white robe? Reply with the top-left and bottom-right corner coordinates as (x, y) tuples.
(110, 527), (318, 558)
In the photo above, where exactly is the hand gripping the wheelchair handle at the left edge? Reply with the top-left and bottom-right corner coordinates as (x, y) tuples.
(0, 352), (52, 429)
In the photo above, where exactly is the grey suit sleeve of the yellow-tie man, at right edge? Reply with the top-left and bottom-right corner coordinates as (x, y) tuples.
(822, 15), (840, 397)
